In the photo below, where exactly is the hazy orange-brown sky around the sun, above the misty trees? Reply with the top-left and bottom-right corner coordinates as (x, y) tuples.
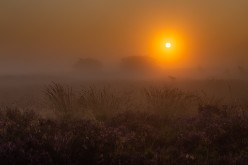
(0, 0), (248, 71)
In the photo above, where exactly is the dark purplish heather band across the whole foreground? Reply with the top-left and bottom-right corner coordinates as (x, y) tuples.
(0, 105), (248, 165)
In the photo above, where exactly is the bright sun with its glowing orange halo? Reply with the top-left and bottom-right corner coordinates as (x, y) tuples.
(149, 30), (192, 69)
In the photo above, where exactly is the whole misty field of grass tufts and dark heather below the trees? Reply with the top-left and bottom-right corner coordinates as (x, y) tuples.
(0, 77), (248, 165)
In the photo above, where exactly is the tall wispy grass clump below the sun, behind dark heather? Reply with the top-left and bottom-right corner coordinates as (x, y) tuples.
(144, 87), (199, 117)
